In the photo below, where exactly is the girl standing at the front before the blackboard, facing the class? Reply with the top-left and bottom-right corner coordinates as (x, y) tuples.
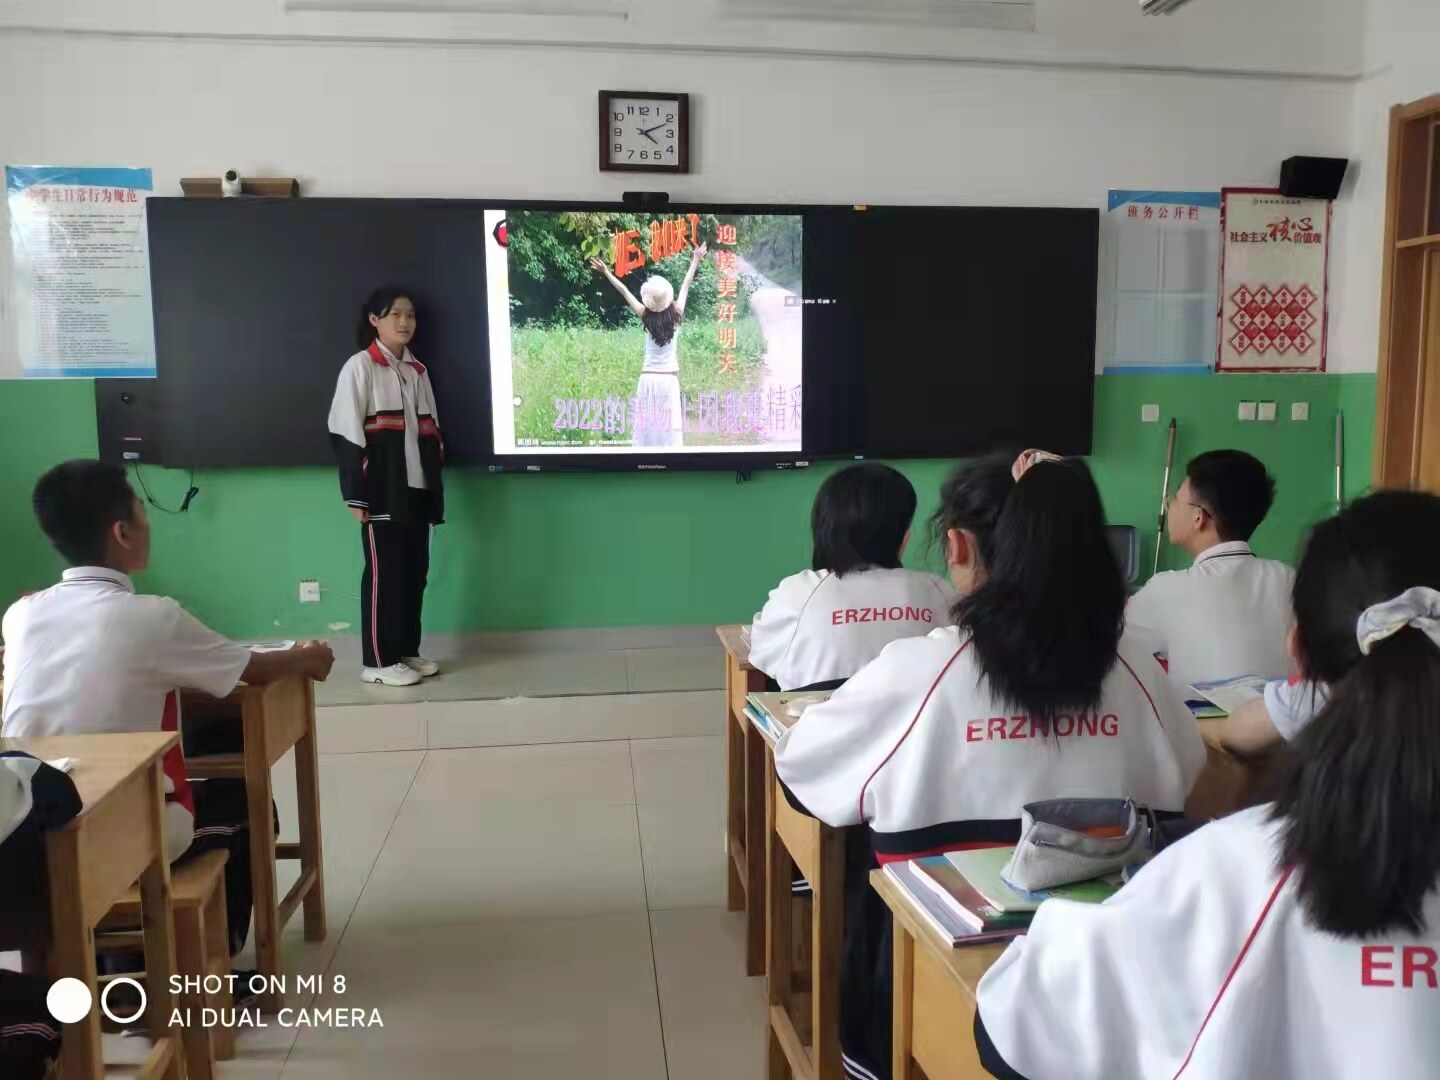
(330, 288), (445, 687)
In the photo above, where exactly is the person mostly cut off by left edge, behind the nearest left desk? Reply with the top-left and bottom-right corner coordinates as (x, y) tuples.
(0, 750), (81, 1080)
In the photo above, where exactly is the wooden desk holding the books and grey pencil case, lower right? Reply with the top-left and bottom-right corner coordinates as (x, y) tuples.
(870, 870), (1005, 1080)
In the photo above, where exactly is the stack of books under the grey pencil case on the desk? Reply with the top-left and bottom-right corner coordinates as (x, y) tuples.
(886, 847), (1120, 945)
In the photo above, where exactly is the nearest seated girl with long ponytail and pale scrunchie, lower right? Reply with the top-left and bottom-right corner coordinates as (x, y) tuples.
(976, 491), (1440, 1080)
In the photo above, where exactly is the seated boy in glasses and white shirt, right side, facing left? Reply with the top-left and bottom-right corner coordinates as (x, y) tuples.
(1125, 451), (1295, 687)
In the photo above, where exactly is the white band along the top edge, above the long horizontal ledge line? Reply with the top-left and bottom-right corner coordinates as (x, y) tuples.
(0, 0), (1362, 75)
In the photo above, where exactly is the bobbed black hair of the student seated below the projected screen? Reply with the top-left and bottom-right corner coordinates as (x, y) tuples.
(811, 461), (916, 577)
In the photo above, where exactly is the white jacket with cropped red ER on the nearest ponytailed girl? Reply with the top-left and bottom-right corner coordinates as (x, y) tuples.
(979, 806), (1440, 1080)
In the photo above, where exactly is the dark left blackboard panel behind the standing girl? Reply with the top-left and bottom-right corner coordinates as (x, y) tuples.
(148, 199), (491, 468)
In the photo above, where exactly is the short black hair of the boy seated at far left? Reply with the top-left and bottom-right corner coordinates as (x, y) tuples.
(32, 461), (135, 566)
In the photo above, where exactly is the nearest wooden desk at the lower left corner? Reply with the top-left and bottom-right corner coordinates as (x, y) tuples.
(0, 732), (184, 1080)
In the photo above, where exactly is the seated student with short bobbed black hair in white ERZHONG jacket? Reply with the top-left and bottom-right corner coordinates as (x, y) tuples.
(750, 462), (955, 690)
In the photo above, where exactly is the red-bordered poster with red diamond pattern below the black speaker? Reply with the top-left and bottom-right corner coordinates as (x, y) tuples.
(1217, 189), (1331, 372)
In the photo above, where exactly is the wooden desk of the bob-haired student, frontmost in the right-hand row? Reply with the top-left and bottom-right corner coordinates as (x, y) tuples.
(716, 625), (766, 975)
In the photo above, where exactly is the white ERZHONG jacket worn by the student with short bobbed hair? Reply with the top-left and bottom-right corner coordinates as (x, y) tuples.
(750, 567), (956, 690)
